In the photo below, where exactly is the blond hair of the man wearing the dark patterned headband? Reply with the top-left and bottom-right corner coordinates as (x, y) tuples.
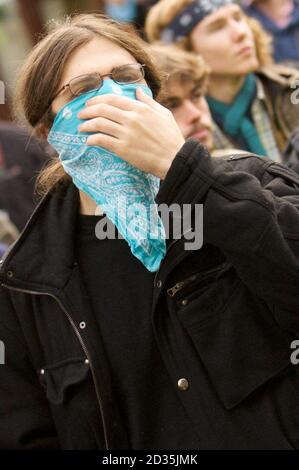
(145, 0), (273, 67)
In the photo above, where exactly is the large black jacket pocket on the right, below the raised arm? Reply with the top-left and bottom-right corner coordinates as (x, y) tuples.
(179, 282), (292, 409)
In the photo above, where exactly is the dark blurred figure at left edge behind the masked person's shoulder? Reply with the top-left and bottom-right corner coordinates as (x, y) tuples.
(0, 121), (50, 232)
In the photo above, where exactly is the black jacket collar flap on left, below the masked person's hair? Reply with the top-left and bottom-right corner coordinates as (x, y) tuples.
(0, 183), (79, 291)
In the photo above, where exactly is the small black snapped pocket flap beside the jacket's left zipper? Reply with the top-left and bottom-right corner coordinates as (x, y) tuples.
(39, 357), (90, 405)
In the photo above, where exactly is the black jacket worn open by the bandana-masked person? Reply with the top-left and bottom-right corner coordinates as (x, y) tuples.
(0, 140), (299, 449)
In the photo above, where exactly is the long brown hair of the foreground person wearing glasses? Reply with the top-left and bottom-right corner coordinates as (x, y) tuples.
(14, 14), (161, 194)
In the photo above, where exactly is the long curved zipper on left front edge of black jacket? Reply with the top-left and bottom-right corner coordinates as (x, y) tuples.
(1, 283), (109, 450)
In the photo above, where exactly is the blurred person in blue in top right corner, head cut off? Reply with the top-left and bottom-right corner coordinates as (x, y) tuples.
(243, 0), (299, 65)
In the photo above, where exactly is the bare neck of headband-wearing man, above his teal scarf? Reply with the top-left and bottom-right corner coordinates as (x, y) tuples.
(208, 75), (246, 104)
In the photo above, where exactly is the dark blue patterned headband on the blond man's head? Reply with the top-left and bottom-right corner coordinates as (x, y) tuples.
(160, 0), (234, 42)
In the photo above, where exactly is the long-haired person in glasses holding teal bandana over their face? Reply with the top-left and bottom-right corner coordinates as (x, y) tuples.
(0, 14), (299, 452)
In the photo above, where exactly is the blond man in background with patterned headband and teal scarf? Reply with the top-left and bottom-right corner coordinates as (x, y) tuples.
(146, 0), (299, 162)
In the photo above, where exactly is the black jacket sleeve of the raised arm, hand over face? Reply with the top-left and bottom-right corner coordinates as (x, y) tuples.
(157, 139), (299, 331)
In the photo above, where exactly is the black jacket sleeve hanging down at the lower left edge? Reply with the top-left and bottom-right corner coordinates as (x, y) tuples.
(0, 287), (59, 449)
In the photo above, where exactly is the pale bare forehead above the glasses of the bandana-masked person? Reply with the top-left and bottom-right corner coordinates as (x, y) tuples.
(61, 37), (136, 85)
